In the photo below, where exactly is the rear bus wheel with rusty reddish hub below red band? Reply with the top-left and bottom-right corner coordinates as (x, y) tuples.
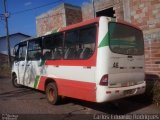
(46, 82), (60, 105)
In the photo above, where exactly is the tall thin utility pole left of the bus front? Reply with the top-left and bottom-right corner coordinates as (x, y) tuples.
(3, 0), (11, 68)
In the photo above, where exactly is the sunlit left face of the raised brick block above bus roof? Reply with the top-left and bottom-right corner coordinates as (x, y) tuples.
(36, 5), (66, 36)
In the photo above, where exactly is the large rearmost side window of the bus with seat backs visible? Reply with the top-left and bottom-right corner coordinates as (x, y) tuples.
(64, 25), (96, 60)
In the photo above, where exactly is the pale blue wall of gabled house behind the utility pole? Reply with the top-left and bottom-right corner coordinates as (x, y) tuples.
(0, 33), (31, 55)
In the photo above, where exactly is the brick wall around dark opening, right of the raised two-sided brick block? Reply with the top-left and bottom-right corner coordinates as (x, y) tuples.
(82, 0), (160, 76)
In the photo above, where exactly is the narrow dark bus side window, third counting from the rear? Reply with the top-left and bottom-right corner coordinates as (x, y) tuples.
(27, 38), (42, 60)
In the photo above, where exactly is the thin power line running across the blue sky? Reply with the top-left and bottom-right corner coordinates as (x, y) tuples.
(11, 0), (63, 15)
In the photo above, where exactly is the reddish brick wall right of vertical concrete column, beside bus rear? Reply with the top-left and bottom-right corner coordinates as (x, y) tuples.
(130, 0), (160, 76)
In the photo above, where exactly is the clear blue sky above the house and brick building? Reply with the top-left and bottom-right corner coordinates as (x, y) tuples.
(0, 0), (90, 36)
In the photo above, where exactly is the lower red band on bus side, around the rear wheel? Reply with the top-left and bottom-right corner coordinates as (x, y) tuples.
(38, 77), (96, 102)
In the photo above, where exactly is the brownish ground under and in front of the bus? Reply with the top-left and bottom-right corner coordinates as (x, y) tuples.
(0, 78), (160, 119)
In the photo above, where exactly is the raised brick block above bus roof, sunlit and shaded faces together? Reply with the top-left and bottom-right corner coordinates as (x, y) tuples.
(36, 4), (82, 36)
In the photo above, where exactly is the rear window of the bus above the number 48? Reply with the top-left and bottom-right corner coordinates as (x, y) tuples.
(109, 22), (144, 55)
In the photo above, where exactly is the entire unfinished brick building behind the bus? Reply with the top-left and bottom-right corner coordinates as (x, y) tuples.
(37, 0), (160, 76)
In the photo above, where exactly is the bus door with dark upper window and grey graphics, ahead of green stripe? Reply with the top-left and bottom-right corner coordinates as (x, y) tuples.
(25, 38), (42, 88)
